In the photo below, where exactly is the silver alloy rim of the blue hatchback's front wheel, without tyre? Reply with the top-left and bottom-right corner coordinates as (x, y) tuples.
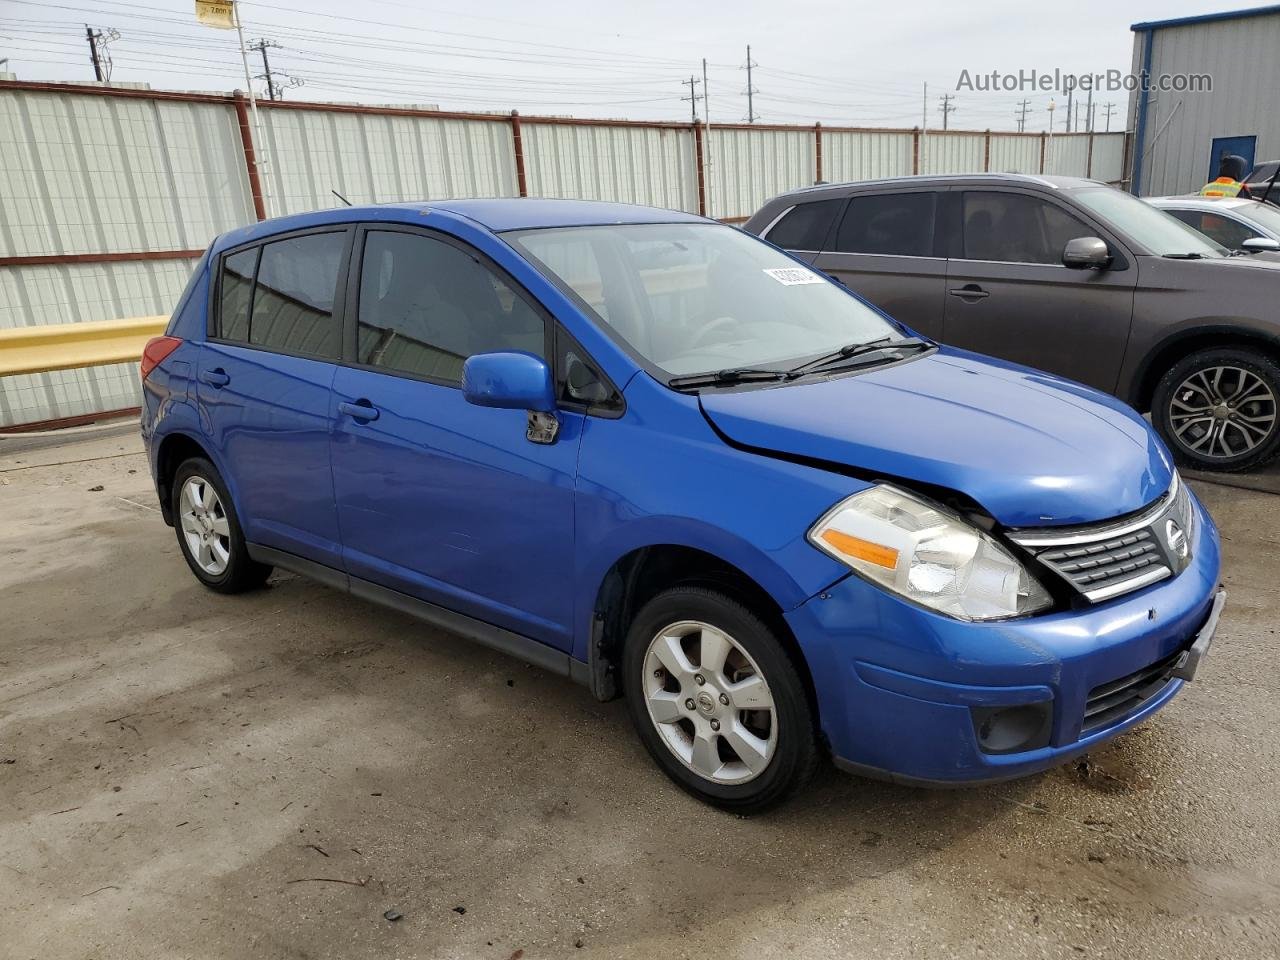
(644, 621), (778, 783)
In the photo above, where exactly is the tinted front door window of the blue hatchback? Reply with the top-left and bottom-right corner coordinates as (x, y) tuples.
(357, 230), (545, 383)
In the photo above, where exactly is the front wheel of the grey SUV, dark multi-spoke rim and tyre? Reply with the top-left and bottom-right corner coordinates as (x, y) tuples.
(1151, 347), (1280, 471)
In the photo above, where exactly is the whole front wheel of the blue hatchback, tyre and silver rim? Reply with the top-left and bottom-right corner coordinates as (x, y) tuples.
(623, 588), (818, 813)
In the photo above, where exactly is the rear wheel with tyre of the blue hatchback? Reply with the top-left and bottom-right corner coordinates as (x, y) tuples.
(173, 457), (271, 594)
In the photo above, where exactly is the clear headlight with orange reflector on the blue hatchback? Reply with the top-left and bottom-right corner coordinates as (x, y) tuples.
(809, 485), (1052, 620)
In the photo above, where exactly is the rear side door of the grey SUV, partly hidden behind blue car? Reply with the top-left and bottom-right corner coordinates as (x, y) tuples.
(813, 188), (947, 338)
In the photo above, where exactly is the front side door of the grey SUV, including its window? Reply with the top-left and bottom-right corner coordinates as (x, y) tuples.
(942, 189), (1138, 393)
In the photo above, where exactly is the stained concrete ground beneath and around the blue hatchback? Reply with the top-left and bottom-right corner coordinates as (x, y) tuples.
(0, 431), (1280, 960)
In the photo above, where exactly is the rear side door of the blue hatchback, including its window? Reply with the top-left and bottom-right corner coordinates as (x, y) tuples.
(197, 227), (353, 567)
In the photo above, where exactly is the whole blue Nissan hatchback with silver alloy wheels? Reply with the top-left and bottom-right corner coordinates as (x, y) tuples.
(142, 200), (1225, 812)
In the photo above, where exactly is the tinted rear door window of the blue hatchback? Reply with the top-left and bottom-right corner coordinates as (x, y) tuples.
(248, 233), (347, 358)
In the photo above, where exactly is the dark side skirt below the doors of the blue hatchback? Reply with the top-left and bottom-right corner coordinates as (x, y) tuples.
(246, 543), (591, 686)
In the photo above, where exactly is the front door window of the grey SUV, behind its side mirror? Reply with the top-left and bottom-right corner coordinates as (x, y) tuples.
(964, 191), (1097, 264)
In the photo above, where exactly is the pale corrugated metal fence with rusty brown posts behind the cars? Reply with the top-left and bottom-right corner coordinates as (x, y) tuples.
(0, 82), (1125, 428)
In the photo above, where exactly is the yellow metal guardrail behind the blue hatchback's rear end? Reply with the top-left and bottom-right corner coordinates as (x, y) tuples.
(0, 316), (169, 376)
